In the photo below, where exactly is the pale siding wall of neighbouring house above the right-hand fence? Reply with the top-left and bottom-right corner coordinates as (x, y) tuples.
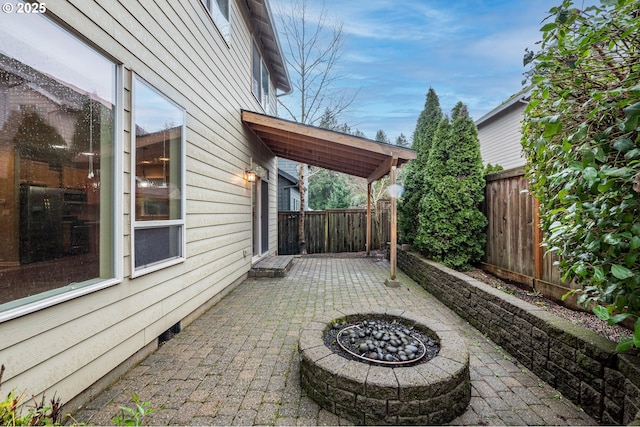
(477, 102), (526, 170)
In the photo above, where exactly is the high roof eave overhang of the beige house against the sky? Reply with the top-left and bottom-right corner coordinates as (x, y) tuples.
(245, 0), (291, 94)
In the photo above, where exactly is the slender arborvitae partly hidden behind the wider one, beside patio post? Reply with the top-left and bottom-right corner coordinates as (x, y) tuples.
(398, 88), (443, 243)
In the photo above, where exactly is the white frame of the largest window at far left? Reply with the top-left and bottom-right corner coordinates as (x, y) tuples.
(0, 64), (124, 324)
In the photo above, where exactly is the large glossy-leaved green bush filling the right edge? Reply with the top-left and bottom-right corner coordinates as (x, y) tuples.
(522, 0), (640, 350)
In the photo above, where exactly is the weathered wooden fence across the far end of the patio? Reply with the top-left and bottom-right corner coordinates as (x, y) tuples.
(278, 203), (391, 255)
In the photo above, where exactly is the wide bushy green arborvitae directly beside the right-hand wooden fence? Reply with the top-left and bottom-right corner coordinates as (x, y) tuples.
(416, 103), (487, 270)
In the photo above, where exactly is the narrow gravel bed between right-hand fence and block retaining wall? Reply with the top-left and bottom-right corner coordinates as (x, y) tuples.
(464, 269), (632, 342)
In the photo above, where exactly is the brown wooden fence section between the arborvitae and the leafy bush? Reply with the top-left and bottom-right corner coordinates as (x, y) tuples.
(483, 169), (572, 300)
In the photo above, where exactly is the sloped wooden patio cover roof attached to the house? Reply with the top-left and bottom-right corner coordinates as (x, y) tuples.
(242, 110), (416, 183)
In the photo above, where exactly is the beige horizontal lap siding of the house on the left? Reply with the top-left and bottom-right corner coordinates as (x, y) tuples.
(0, 0), (278, 402)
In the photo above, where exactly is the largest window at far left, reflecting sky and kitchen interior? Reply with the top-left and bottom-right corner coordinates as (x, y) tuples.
(0, 1), (120, 320)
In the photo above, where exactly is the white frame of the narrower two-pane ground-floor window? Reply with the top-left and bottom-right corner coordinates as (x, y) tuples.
(129, 72), (187, 279)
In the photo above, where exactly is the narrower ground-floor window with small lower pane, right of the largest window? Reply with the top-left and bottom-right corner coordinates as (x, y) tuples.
(132, 76), (185, 275)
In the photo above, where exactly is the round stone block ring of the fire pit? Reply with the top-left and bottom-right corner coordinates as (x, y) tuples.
(298, 310), (471, 425)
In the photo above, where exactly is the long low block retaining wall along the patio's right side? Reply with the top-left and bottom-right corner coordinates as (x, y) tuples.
(398, 250), (640, 425)
